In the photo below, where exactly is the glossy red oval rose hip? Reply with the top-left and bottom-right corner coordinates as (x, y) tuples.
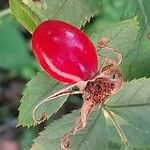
(32, 20), (98, 83)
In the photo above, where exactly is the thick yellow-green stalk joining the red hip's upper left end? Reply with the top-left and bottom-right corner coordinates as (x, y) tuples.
(9, 0), (41, 33)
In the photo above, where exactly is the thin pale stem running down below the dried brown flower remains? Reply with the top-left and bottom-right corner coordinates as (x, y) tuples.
(103, 106), (129, 150)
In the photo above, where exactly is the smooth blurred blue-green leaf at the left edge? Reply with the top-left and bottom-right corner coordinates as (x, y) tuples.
(0, 10), (32, 71)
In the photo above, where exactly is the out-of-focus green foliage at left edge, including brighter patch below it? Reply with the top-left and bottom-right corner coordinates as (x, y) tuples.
(0, 10), (38, 79)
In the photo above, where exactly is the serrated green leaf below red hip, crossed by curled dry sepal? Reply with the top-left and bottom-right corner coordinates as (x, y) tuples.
(18, 73), (68, 127)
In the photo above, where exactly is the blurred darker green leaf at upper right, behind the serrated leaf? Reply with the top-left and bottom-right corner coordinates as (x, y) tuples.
(86, 0), (150, 80)
